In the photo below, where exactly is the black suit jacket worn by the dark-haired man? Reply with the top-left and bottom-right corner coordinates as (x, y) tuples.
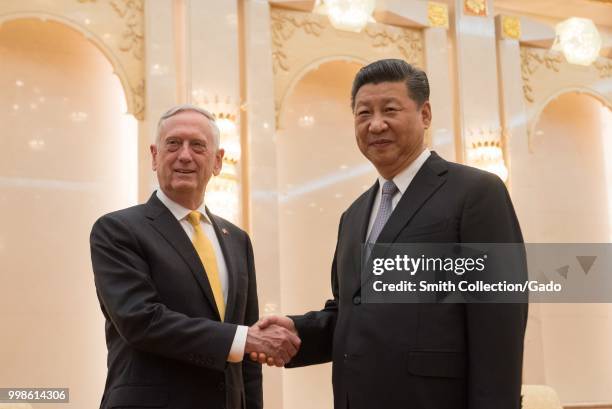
(289, 153), (527, 409)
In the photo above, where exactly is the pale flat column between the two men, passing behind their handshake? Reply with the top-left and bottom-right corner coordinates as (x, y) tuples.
(243, 0), (283, 409)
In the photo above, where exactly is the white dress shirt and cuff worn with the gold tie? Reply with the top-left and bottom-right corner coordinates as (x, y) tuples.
(156, 189), (249, 362)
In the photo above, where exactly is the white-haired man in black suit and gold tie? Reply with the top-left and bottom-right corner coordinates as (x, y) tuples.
(91, 105), (299, 409)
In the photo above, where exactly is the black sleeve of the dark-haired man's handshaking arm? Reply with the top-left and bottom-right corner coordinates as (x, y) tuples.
(286, 215), (344, 368)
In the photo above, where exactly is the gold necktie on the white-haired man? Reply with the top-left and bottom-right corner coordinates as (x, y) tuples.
(187, 211), (225, 321)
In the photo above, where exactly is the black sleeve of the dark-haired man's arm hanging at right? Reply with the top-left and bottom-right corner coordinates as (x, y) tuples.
(460, 174), (527, 409)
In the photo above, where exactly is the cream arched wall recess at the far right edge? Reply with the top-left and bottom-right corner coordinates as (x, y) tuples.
(512, 91), (612, 404)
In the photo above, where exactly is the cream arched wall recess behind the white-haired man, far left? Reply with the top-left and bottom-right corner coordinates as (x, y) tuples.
(0, 19), (137, 408)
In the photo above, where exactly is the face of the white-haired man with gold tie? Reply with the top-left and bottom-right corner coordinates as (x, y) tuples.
(151, 111), (224, 203)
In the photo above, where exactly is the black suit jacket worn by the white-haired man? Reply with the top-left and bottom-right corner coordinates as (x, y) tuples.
(91, 194), (263, 409)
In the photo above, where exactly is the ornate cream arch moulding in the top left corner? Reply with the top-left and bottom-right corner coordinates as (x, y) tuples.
(0, 0), (146, 120)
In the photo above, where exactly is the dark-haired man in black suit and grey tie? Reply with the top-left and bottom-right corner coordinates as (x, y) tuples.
(251, 60), (527, 409)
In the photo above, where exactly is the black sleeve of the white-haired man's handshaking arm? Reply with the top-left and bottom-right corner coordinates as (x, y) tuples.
(90, 214), (237, 371)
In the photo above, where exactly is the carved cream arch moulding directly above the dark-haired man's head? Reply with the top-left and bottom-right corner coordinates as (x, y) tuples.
(270, 7), (425, 127)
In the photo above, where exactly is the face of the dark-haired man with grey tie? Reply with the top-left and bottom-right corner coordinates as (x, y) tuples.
(354, 81), (431, 179)
